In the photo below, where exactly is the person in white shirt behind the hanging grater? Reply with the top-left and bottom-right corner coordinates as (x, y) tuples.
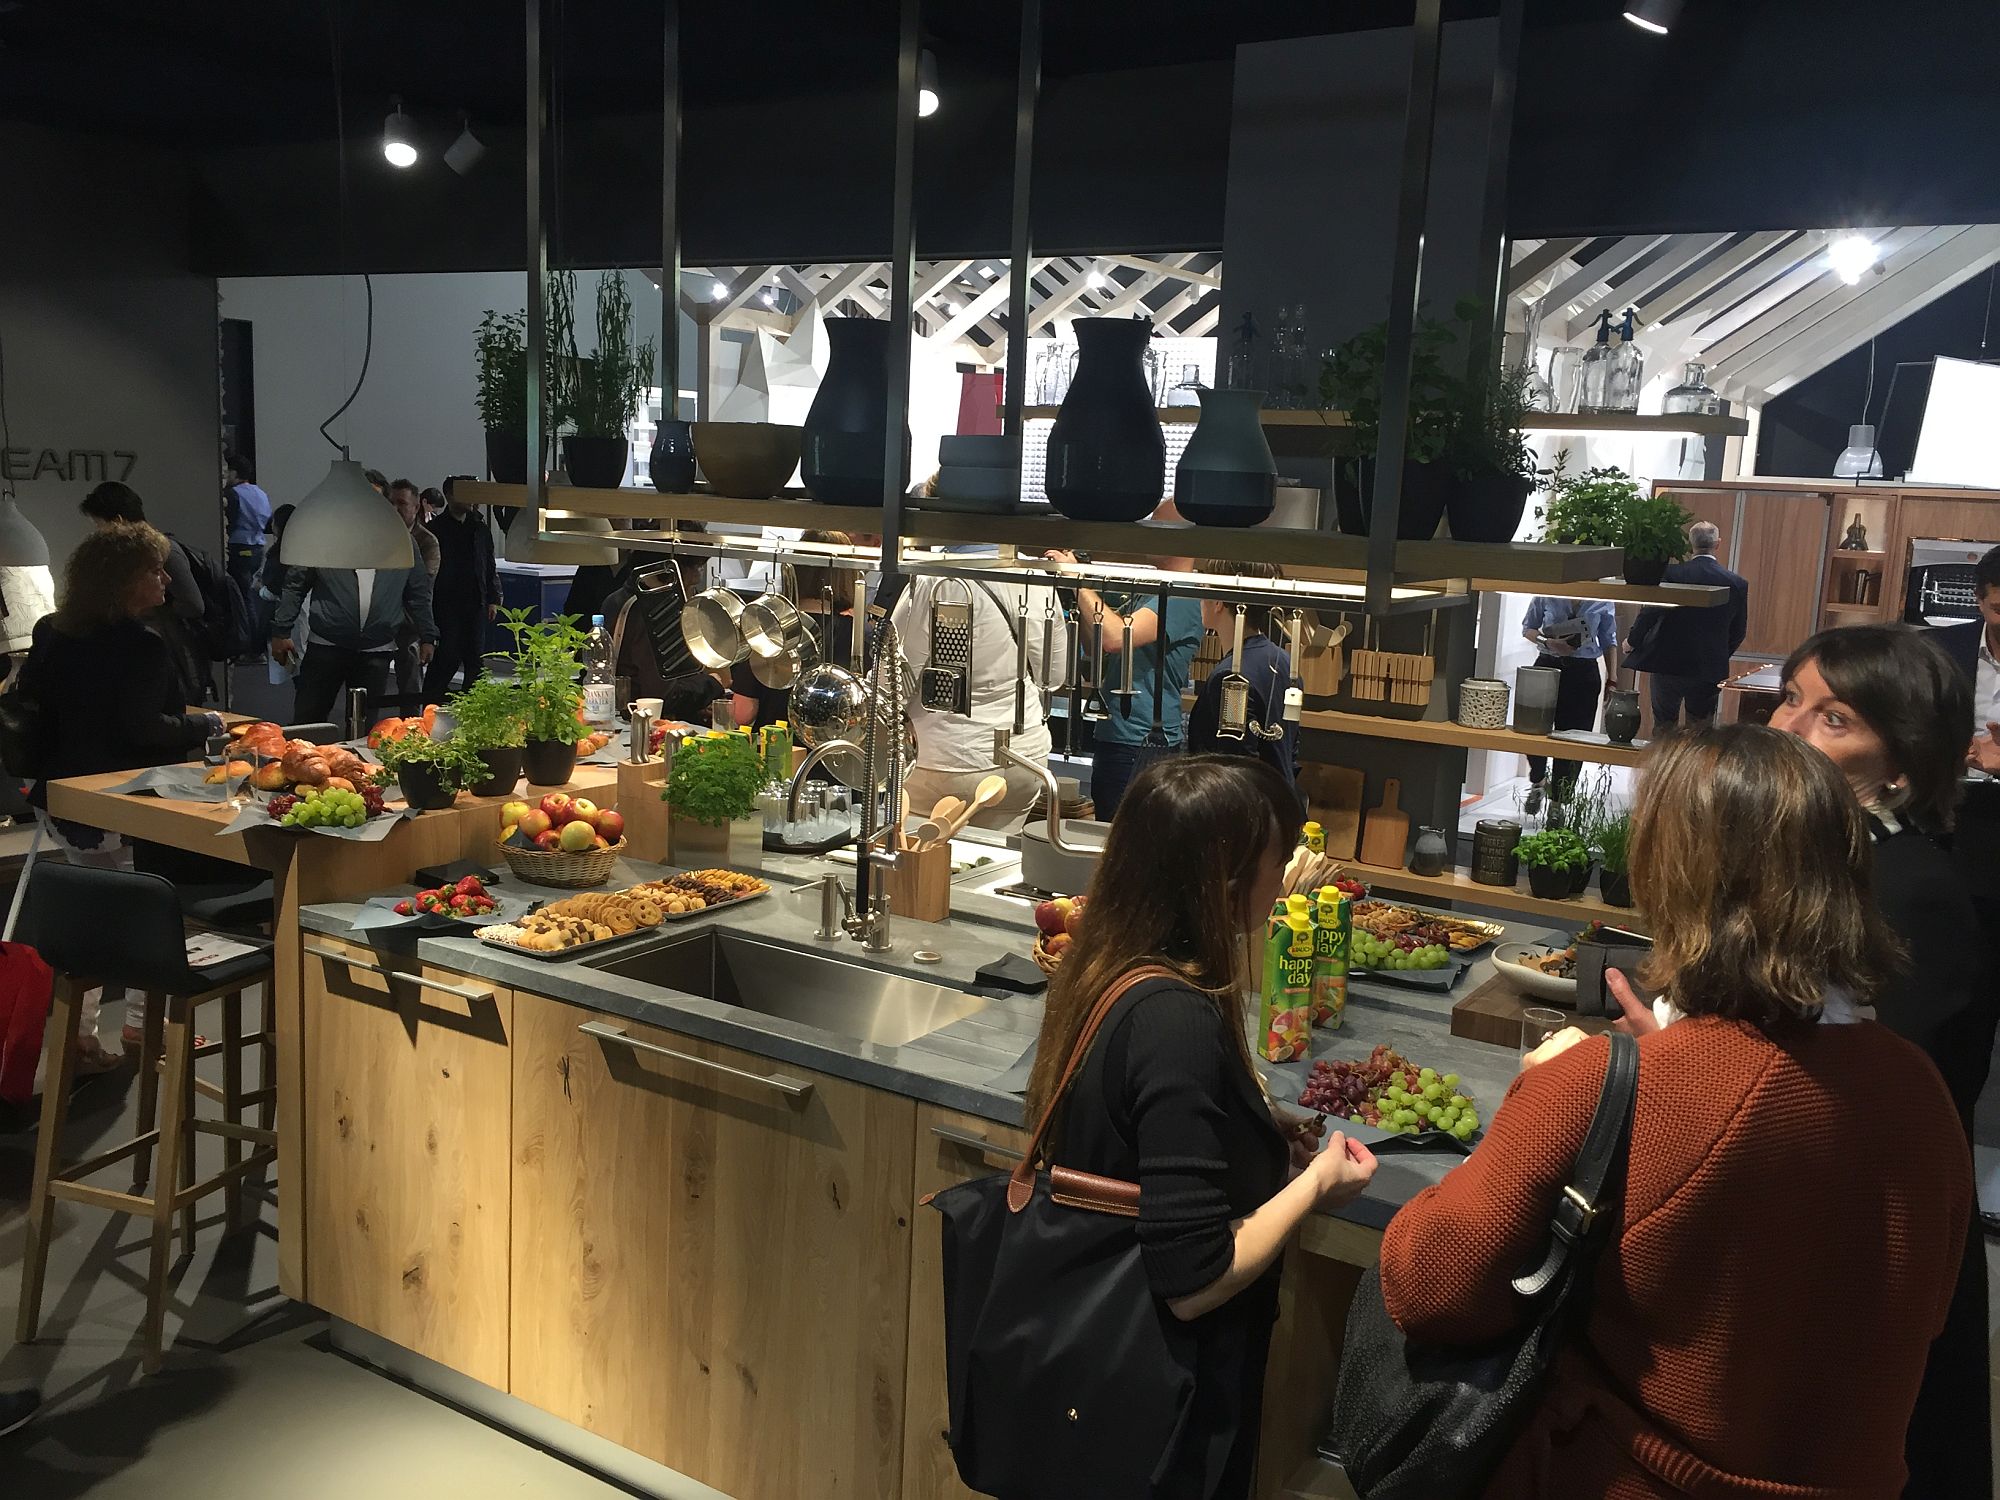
(890, 578), (1064, 828)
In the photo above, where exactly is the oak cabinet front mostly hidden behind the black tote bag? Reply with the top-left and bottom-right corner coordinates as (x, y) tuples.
(902, 1104), (1028, 1500)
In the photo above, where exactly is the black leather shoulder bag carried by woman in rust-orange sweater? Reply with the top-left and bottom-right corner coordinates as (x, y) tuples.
(1320, 1032), (1638, 1500)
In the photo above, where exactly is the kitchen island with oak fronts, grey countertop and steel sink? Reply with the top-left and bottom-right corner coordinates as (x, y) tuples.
(300, 860), (1544, 1500)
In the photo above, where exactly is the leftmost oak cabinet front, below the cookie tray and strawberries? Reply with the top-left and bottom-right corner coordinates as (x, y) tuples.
(302, 934), (514, 1390)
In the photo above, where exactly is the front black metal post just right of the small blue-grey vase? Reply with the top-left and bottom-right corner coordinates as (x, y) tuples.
(1366, 0), (1442, 614)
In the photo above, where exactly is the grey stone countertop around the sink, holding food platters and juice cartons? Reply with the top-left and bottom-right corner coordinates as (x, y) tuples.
(300, 856), (1576, 1228)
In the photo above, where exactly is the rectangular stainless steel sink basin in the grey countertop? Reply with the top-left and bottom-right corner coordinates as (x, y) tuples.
(586, 928), (986, 1046)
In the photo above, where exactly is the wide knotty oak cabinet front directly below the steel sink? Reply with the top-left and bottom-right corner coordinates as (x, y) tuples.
(510, 994), (916, 1500)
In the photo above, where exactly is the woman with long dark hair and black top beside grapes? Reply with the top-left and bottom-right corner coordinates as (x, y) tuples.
(1010, 756), (1374, 1500)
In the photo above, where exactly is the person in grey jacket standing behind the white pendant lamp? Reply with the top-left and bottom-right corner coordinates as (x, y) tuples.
(270, 542), (438, 724)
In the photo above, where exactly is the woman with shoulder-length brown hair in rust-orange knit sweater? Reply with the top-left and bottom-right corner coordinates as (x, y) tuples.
(1382, 726), (1972, 1500)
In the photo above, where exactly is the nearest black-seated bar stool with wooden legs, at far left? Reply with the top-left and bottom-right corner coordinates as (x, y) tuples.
(16, 864), (278, 1374)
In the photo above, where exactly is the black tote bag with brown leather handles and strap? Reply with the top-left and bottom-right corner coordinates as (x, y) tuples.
(926, 968), (1194, 1500)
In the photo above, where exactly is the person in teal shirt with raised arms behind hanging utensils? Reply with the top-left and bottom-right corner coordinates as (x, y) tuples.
(1050, 552), (1202, 822)
